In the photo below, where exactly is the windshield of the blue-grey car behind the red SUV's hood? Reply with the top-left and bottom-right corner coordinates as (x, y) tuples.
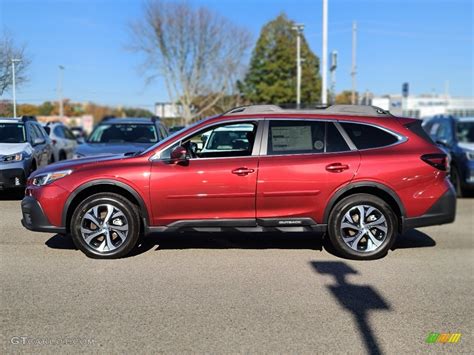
(88, 123), (158, 144)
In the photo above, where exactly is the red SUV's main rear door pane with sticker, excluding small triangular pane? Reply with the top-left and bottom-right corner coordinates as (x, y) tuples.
(267, 120), (326, 155)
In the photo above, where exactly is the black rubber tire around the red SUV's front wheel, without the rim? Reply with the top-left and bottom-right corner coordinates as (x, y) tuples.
(71, 194), (139, 259)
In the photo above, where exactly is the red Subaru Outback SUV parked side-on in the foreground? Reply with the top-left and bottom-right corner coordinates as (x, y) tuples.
(22, 105), (456, 259)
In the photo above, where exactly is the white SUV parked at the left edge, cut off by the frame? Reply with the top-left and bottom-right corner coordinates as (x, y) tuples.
(0, 116), (53, 190)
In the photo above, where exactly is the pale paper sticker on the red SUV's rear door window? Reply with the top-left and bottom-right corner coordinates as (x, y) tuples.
(272, 126), (313, 152)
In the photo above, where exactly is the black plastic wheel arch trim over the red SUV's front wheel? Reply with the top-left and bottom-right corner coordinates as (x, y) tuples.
(61, 179), (149, 232)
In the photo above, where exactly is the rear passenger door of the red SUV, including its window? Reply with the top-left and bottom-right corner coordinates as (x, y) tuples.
(256, 119), (360, 226)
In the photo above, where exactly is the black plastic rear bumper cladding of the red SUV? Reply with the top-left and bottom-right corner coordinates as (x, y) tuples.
(403, 184), (456, 232)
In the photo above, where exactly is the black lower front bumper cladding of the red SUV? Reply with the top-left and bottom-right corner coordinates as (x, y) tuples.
(21, 196), (66, 234)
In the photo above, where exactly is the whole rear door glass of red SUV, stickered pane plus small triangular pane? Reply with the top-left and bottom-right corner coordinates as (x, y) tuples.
(267, 120), (350, 155)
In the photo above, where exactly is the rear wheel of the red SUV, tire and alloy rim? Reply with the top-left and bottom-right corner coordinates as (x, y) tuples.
(328, 194), (398, 260)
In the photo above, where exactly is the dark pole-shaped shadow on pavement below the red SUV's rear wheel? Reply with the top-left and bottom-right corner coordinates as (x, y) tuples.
(311, 261), (391, 354)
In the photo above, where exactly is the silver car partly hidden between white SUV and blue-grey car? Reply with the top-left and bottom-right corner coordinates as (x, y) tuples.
(43, 122), (77, 162)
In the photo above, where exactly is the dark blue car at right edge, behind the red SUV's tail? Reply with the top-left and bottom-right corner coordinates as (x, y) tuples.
(423, 116), (474, 197)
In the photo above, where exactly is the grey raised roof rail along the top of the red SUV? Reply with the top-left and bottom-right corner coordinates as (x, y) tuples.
(224, 105), (391, 117)
